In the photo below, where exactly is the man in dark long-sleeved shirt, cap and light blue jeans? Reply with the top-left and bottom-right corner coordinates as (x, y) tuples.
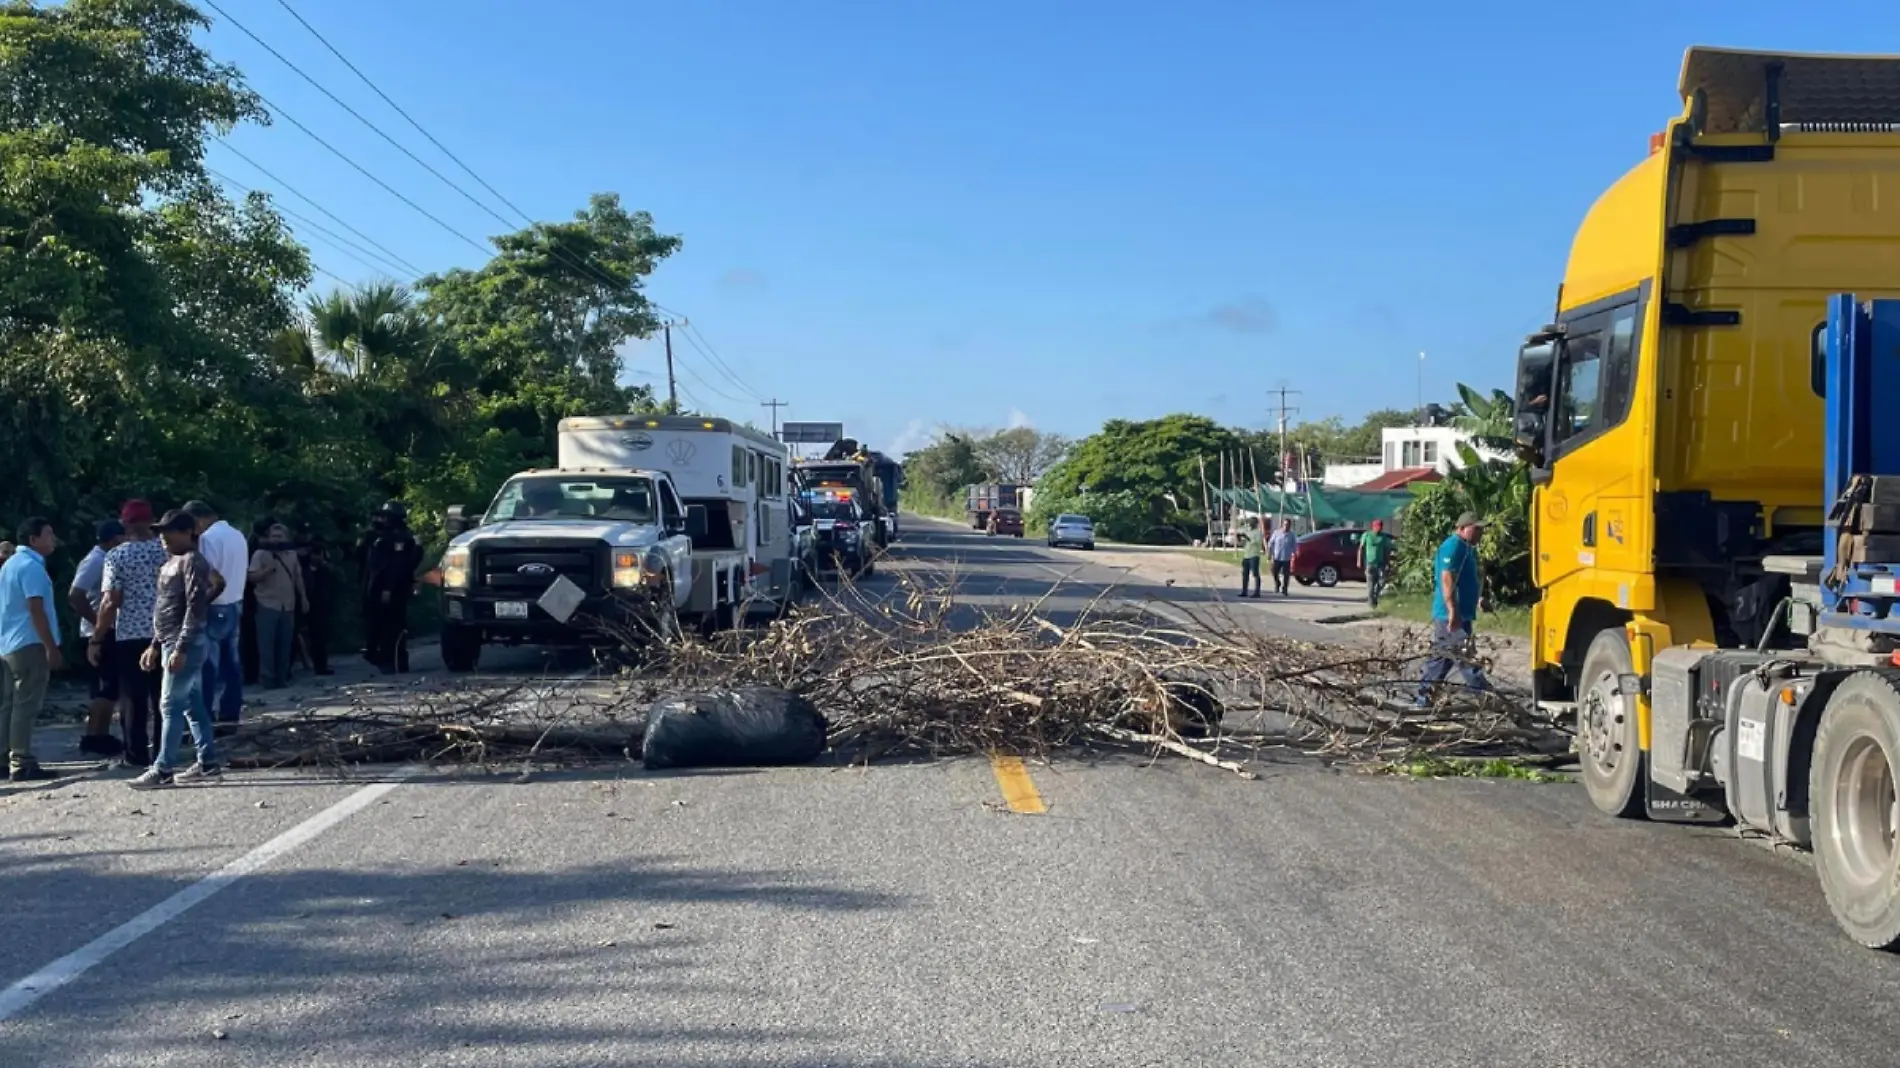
(125, 511), (224, 791)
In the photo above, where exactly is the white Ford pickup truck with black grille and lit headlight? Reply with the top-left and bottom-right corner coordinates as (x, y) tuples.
(441, 467), (747, 671)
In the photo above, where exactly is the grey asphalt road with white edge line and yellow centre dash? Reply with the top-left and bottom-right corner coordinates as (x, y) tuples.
(0, 524), (1900, 1068)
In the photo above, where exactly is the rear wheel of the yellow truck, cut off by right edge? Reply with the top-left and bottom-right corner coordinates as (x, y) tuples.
(1809, 671), (1900, 950)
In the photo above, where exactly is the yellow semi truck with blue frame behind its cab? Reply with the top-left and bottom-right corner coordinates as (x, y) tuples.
(1514, 48), (1900, 948)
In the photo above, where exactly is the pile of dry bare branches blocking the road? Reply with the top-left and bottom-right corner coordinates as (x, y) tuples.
(218, 570), (1566, 775)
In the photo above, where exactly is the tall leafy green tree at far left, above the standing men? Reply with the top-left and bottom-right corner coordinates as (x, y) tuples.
(0, 0), (310, 517)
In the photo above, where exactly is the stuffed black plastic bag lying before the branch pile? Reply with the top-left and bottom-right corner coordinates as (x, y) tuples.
(640, 686), (830, 768)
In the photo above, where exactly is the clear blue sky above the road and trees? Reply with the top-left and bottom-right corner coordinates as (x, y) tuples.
(207, 0), (1869, 448)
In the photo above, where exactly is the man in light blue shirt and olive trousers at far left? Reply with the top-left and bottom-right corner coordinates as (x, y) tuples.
(0, 517), (67, 783)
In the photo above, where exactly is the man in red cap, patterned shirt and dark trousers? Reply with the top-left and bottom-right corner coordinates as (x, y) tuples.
(86, 500), (165, 768)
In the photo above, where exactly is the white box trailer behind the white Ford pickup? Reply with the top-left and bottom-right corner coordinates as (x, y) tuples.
(559, 416), (798, 612)
